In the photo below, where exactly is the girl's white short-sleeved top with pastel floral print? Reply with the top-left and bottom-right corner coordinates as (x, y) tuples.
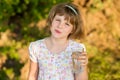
(29, 39), (85, 80)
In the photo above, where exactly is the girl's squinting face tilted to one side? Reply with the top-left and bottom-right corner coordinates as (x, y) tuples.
(50, 15), (73, 39)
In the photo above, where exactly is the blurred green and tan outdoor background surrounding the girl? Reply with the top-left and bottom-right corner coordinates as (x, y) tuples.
(0, 0), (120, 80)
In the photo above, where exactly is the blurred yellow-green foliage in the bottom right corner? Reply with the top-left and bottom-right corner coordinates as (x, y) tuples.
(89, 49), (120, 80)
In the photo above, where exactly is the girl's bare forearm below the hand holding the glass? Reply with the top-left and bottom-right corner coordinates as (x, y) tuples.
(75, 66), (88, 80)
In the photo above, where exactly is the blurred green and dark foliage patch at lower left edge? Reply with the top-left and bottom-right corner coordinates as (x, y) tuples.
(0, 42), (24, 80)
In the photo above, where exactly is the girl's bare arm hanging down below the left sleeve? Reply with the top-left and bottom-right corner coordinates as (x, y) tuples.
(28, 60), (38, 80)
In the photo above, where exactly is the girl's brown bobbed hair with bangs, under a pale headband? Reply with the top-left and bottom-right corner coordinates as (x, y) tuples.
(47, 3), (85, 39)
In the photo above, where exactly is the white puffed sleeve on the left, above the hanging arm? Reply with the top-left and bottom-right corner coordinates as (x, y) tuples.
(29, 42), (37, 63)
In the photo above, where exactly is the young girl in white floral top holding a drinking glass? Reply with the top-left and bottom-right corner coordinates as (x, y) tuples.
(28, 3), (88, 80)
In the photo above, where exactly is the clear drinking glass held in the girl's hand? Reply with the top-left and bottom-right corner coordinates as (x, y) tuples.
(72, 48), (84, 73)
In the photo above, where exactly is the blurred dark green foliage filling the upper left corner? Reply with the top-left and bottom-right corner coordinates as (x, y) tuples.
(0, 0), (71, 43)
